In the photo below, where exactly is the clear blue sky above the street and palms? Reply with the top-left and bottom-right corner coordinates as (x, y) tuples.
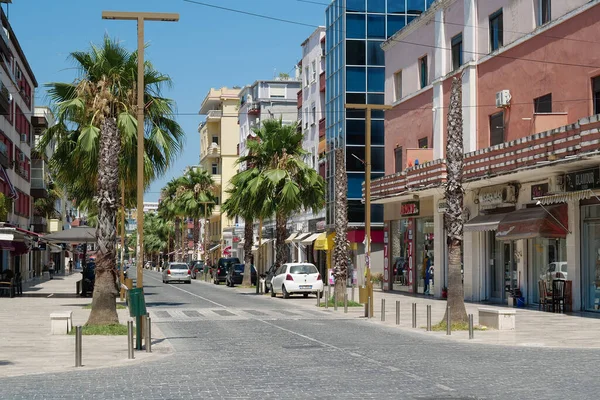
(3, 0), (328, 201)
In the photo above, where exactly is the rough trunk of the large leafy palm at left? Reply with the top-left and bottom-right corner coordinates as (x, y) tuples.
(87, 118), (121, 325)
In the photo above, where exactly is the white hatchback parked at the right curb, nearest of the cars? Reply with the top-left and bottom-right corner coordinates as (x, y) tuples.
(271, 263), (323, 299)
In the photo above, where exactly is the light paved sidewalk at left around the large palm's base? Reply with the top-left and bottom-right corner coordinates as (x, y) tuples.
(0, 272), (172, 378)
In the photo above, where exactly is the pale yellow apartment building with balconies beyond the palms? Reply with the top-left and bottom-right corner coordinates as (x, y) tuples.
(198, 87), (241, 261)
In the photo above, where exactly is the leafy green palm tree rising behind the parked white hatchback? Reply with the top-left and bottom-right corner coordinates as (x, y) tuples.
(239, 119), (325, 266)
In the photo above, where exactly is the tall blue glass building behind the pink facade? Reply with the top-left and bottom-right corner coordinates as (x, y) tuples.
(325, 0), (434, 226)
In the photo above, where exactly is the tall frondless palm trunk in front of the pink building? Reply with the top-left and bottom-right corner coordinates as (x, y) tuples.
(442, 78), (468, 323)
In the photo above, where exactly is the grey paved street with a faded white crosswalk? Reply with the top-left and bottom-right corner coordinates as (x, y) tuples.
(0, 272), (600, 399)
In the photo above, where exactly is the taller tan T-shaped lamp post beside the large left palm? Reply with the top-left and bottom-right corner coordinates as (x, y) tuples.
(102, 11), (179, 288)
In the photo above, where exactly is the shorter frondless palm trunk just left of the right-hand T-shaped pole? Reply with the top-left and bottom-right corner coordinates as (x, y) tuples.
(336, 148), (350, 302)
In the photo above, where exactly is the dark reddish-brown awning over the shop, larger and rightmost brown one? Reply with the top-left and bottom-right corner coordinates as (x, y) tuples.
(496, 204), (568, 240)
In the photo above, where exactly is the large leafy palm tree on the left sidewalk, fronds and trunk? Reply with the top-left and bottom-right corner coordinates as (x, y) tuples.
(40, 37), (183, 325)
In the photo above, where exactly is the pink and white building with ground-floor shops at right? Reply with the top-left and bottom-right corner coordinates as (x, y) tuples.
(372, 0), (600, 310)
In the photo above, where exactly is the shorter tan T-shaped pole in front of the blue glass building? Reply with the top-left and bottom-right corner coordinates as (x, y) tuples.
(344, 103), (392, 315)
